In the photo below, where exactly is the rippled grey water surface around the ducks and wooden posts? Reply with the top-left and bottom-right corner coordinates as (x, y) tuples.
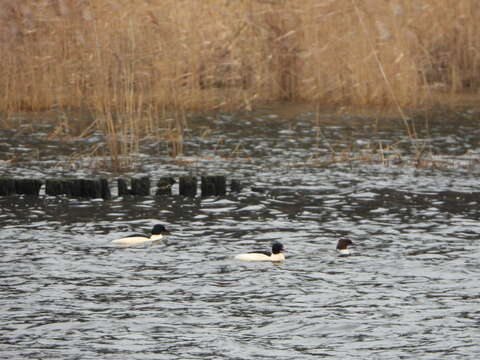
(0, 108), (480, 359)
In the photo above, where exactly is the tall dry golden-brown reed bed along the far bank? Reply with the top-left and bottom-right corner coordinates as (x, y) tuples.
(0, 0), (480, 168)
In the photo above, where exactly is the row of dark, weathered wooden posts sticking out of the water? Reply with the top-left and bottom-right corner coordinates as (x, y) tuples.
(0, 176), (241, 199)
